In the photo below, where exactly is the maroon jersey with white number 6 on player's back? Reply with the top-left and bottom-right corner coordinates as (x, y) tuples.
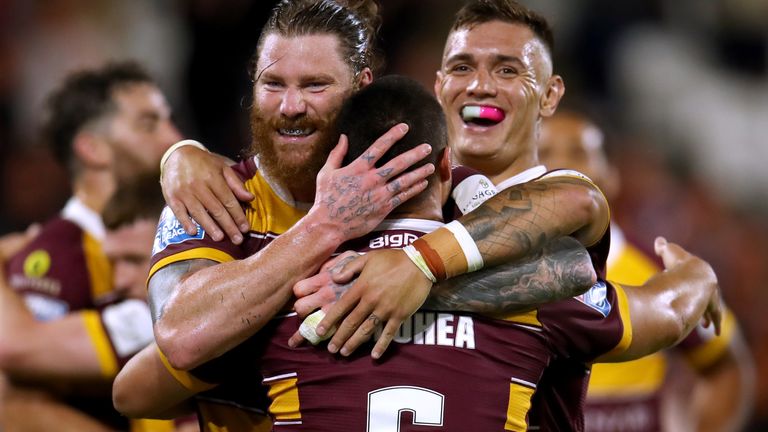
(188, 219), (622, 431)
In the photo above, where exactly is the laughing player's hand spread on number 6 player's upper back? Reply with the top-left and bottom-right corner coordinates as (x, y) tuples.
(310, 249), (432, 358)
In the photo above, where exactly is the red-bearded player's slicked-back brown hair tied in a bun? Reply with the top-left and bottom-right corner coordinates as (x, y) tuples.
(251, 0), (381, 75)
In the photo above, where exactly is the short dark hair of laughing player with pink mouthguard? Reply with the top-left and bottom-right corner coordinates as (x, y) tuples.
(451, 0), (555, 56)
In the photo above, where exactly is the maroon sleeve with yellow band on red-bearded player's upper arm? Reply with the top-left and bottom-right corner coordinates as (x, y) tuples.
(149, 207), (245, 278)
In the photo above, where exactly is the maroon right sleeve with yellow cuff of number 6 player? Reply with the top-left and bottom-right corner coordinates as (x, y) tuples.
(539, 280), (632, 363)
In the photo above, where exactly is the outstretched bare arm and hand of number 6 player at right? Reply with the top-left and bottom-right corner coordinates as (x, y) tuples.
(596, 239), (721, 362)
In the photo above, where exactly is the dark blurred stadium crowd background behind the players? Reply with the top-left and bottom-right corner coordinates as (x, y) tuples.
(0, 0), (768, 430)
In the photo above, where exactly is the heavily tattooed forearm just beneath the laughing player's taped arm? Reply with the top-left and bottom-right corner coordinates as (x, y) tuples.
(423, 237), (596, 316)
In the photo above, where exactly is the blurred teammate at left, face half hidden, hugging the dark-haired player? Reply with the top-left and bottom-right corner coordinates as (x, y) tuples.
(0, 173), (197, 432)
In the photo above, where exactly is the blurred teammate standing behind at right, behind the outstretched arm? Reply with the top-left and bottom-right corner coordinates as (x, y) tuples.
(539, 111), (754, 432)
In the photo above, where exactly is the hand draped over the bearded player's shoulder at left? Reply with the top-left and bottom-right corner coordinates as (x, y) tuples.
(160, 142), (253, 244)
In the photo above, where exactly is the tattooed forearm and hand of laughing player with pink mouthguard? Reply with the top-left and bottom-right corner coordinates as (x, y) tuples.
(317, 175), (610, 357)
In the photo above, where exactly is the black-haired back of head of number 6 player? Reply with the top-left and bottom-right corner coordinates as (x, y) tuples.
(337, 75), (448, 168)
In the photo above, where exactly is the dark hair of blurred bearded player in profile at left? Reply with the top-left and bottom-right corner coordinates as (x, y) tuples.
(43, 62), (154, 172)
